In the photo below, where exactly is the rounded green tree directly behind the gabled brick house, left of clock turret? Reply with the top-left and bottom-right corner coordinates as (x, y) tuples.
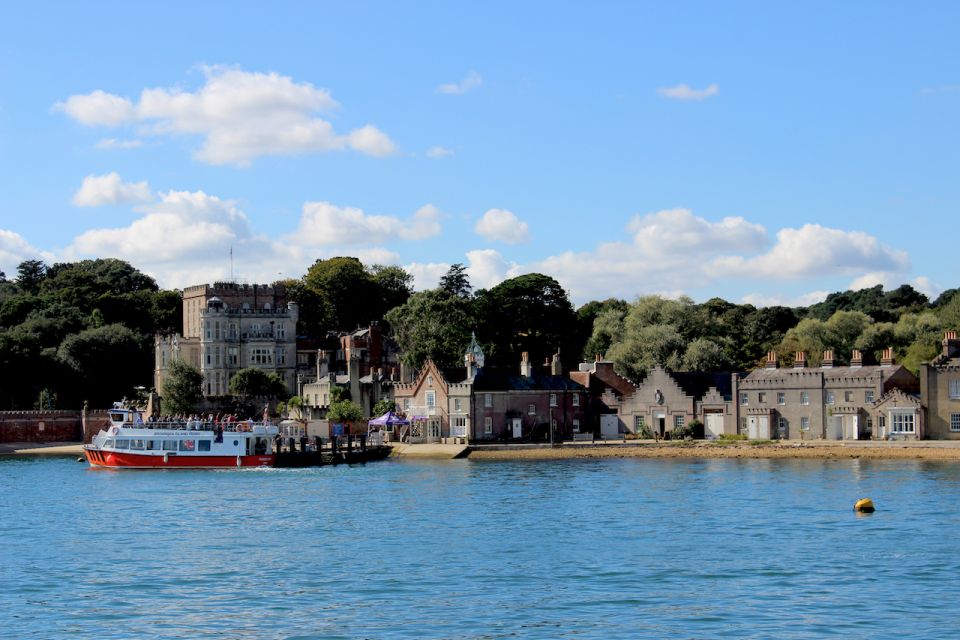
(386, 289), (473, 368)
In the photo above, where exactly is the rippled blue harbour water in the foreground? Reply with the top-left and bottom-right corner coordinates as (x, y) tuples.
(0, 458), (960, 639)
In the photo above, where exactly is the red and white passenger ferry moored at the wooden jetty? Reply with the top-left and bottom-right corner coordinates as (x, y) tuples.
(83, 403), (278, 469)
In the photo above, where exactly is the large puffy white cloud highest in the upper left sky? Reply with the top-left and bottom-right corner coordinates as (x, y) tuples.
(55, 67), (397, 166)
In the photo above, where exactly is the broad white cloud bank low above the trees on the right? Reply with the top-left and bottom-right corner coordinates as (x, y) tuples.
(524, 209), (909, 301)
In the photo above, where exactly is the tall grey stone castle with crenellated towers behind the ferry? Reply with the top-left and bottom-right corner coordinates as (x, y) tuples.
(154, 282), (298, 396)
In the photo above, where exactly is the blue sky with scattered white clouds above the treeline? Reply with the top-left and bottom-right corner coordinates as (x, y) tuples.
(0, 2), (960, 304)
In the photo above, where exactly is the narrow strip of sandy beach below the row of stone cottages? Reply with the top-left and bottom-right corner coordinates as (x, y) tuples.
(469, 441), (960, 460)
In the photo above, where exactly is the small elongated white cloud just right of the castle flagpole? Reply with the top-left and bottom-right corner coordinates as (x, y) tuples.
(290, 202), (441, 246)
